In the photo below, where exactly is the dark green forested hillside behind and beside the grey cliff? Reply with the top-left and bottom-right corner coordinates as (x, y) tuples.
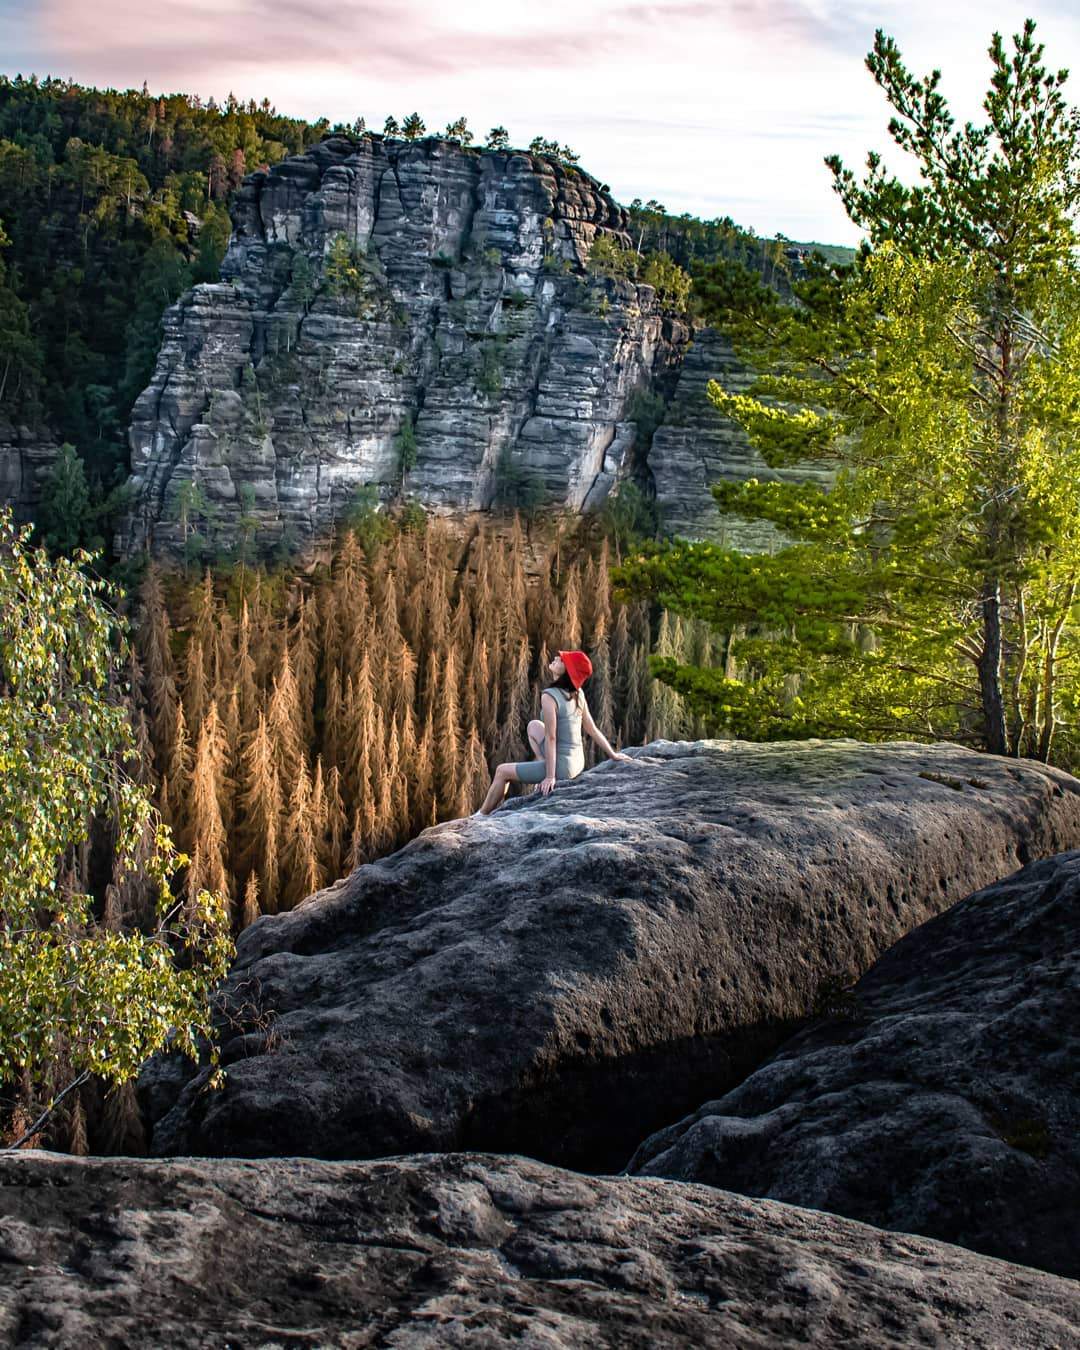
(0, 76), (847, 558)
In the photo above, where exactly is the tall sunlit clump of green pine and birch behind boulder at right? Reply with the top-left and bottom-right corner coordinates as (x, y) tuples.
(618, 20), (1080, 761)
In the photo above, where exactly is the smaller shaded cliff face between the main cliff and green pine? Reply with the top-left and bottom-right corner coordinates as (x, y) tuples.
(648, 328), (832, 552)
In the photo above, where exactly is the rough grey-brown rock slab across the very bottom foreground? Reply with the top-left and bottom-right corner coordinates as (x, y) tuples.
(0, 1153), (1080, 1350)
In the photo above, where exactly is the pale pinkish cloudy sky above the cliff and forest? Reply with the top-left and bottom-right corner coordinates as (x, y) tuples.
(0, 0), (1080, 244)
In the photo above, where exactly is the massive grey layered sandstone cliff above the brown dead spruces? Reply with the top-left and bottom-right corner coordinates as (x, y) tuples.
(117, 136), (689, 555)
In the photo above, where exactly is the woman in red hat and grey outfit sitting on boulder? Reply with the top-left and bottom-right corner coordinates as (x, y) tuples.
(474, 652), (630, 815)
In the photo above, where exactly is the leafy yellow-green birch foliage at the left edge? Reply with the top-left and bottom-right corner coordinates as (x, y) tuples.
(0, 512), (232, 1142)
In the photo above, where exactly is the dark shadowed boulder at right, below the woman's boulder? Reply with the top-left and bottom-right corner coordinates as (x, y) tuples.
(630, 852), (1080, 1277)
